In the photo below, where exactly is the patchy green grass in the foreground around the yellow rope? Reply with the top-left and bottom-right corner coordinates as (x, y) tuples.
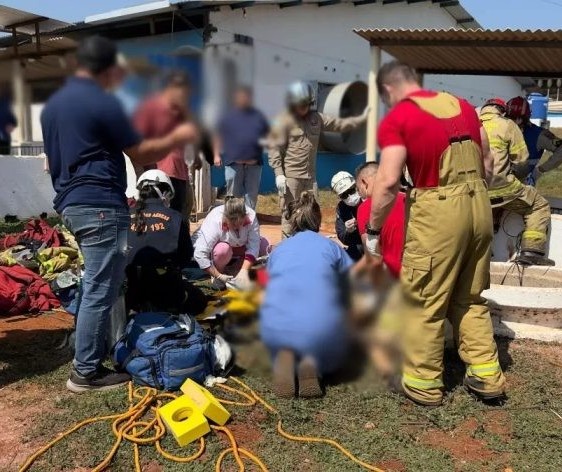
(10, 332), (562, 472)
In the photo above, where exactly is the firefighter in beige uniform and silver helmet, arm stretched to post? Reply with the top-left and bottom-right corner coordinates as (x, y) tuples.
(268, 81), (367, 237)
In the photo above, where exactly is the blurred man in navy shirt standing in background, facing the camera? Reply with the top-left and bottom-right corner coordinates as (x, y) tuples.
(215, 87), (269, 210)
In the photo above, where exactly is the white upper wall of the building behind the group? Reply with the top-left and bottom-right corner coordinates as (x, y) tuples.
(210, 2), (521, 117)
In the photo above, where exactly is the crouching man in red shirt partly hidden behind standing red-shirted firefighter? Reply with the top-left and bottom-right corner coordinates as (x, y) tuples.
(355, 162), (406, 279)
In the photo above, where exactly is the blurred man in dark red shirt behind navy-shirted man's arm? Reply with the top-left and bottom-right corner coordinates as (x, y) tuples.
(134, 72), (195, 221)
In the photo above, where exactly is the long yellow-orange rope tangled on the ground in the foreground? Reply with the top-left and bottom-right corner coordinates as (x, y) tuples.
(19, 377), (383, 472)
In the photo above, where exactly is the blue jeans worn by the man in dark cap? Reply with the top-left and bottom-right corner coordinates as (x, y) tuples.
(62, 205), (130, 375)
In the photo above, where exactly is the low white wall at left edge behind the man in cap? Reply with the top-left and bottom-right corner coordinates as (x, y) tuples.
(0, 156), (55, 218)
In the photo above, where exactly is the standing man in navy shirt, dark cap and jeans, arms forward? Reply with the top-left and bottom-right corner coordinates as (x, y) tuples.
(41, 36), (196, 392)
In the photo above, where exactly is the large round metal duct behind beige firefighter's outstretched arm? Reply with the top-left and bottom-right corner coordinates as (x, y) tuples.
(318, 81), (369, 154)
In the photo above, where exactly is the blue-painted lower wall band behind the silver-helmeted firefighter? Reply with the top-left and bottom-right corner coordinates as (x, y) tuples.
(211, 152), (365, 193)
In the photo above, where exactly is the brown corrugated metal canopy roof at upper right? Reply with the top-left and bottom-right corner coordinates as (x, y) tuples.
(355, 29), (562, 77)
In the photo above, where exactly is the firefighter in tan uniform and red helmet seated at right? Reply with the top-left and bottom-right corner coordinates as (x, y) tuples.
(480, 98), (554, 265)
